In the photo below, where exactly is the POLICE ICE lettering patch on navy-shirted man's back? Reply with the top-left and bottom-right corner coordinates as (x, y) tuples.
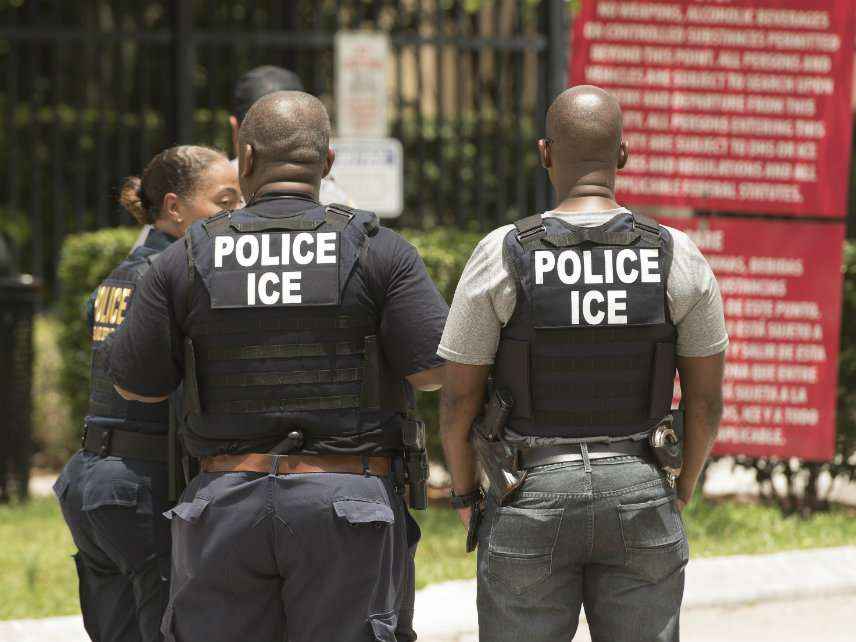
(213, 232), (339, 307)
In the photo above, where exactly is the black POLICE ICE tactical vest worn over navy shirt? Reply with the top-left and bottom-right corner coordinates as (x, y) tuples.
(184, 196), (408, 456)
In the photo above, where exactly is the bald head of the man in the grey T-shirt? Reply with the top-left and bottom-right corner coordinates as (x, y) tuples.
(547, 85), (621, 167)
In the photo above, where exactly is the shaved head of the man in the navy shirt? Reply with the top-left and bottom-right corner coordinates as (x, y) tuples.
(238, 91), (330, 189)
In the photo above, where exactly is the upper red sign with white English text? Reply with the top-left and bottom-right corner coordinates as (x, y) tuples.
(569, 0), (856, 217)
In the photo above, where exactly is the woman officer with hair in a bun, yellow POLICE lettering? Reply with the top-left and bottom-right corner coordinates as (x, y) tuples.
(54, 145), (240, 642)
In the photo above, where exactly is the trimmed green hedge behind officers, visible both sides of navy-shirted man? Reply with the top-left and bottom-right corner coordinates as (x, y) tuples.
(57, 227), (480, 454)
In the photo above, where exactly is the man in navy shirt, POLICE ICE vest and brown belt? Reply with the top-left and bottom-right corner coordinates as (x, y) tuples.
(109, 92), (448, 642)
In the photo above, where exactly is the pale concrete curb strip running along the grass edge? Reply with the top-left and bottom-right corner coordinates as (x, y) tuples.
(6, 546), (856, 642)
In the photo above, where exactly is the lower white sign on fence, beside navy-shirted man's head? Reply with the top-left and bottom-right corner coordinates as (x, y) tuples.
(331, 138), (404, 218)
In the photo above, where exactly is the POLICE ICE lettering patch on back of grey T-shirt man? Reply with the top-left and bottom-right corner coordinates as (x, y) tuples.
(533, 248), (662, 327)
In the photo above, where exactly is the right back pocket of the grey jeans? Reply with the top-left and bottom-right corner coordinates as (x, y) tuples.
(618, 495), (689, 584)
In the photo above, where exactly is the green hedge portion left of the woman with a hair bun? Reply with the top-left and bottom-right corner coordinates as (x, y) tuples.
(56, 227), (140, 436)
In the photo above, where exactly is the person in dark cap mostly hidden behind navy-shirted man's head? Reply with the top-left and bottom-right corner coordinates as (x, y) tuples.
(229, 65), (354, 207)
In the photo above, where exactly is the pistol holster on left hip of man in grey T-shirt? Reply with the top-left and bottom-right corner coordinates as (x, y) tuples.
(470, 389), (527, 506)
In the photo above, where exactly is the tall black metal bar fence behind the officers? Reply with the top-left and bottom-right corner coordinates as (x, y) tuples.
(0, 0), (568, 284)
